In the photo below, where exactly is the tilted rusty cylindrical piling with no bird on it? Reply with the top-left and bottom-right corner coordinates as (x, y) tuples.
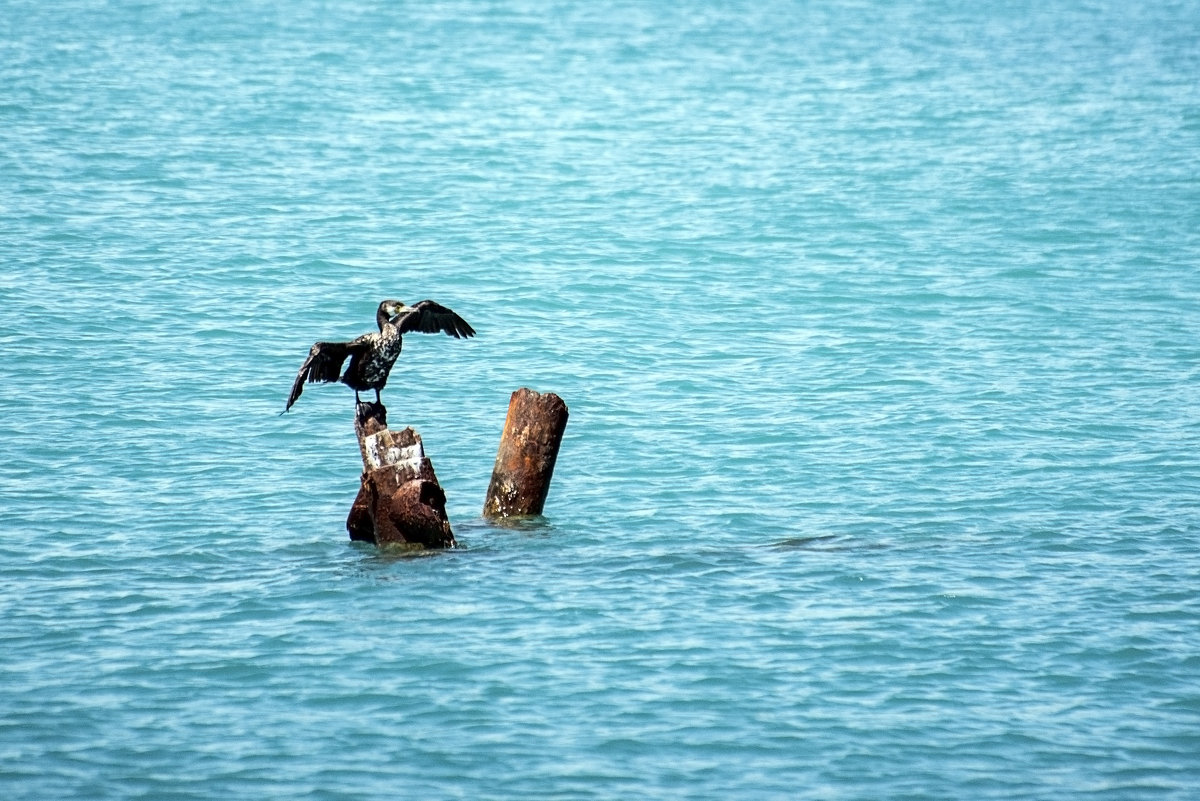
(484, 387), (566, 518)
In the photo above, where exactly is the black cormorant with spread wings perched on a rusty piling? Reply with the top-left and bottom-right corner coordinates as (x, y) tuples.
(283, 300), (475, 411)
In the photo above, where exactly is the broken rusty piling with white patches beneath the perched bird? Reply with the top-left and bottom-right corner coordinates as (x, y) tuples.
(346, 403), (455, 548)
